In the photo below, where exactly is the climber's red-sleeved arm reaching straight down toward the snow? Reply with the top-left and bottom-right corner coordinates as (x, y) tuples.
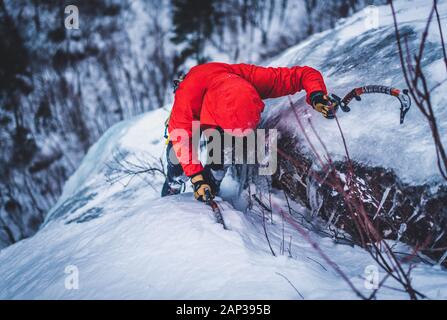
(168, 84), (203, 177)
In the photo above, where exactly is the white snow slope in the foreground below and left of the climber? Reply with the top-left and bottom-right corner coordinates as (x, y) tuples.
(0, 109), (447, 299)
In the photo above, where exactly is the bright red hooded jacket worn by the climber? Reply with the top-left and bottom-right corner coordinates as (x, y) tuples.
(168, 63), (327, 176)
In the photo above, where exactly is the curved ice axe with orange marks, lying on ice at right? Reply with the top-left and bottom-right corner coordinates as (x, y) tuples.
(329, 85), (411, 124)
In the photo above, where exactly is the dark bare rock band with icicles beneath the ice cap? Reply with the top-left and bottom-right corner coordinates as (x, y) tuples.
(273, 132), (447, 266)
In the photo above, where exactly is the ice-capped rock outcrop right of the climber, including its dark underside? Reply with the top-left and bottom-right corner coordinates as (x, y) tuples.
(263, 0), (447, 265)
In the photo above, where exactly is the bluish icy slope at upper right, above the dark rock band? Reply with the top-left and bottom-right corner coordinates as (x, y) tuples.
(264, 0), (447, 184)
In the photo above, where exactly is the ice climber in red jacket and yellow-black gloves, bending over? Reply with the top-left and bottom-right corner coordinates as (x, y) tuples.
(162, 62), (337, 201)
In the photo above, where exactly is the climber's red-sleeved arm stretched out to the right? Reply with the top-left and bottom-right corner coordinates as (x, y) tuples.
(231, 64), (327, 105)
